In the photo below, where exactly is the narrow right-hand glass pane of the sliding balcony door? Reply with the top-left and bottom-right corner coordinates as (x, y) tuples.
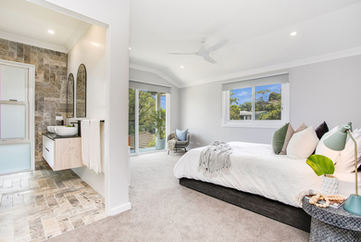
(155, 93), (167, 150)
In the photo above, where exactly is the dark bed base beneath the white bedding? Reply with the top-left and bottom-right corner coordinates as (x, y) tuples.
(179, 178), (311, 232)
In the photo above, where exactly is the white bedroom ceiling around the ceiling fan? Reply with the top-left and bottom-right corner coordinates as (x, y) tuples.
(131, 0), (361, 86)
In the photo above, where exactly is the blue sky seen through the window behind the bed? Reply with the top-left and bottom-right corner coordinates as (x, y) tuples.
(232, 84), (281, 105)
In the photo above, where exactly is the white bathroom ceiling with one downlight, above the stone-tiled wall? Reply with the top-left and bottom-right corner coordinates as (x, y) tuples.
(0, 0), (90, 52)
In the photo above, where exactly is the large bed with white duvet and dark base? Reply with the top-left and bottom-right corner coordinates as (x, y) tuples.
(173, 142), (354, 231)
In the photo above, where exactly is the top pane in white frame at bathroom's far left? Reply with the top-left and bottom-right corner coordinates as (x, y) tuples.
(0, 65), (27, 101)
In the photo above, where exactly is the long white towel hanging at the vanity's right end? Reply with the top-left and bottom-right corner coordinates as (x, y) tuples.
(81, 120), (102, 174)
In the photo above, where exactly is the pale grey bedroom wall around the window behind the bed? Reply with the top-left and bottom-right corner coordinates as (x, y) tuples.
(180, 56), (361, 147)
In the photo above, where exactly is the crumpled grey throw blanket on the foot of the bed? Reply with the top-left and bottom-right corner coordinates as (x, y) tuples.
(199, 141), (232, 174)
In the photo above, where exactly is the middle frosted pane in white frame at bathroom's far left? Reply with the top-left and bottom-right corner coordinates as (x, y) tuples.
(0, 104), (26, 139)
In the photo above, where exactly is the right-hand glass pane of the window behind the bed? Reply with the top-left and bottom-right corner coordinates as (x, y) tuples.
(255, 84), (281, 120)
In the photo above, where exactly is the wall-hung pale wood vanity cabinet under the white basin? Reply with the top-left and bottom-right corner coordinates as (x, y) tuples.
(43, 133), (83, 171)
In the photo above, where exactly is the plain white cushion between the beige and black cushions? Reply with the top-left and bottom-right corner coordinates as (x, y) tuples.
(287, 127), (319, 159)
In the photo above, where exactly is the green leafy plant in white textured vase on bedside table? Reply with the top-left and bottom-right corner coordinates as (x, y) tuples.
(306, 155), (338, 195)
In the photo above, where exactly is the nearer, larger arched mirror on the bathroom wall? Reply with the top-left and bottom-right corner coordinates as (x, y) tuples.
(75, 64), (86, 118)
